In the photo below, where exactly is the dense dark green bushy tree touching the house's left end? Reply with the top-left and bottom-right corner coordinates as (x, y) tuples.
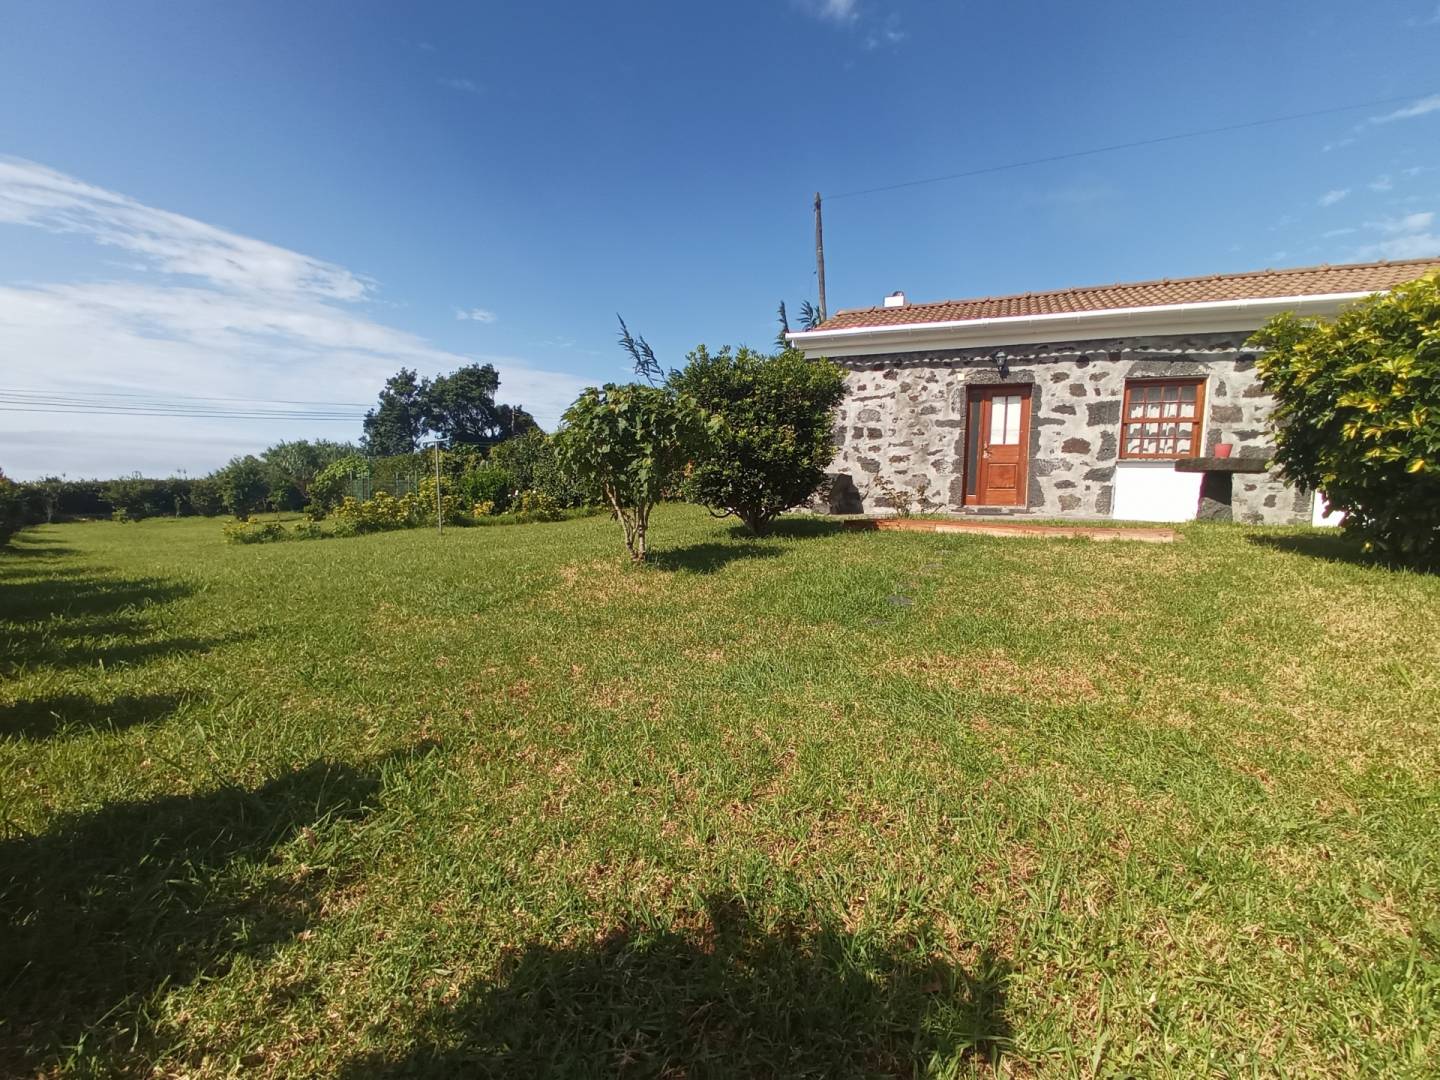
(667, 346), (845, 534)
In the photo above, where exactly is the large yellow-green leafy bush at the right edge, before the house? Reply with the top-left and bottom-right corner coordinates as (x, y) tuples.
(1250, 274), (1440, 566)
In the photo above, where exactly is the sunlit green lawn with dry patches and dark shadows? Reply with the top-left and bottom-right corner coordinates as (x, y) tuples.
(0, 508), (1440, 1079)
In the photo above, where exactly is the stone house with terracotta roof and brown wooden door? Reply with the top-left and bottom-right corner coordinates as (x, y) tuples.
(789, 259), (1440, 524)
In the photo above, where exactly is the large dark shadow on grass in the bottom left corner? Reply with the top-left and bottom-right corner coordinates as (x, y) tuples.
(0, 747), (423, 1076)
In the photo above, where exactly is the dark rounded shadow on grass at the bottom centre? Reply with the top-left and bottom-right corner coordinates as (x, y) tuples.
(341, 901), (1011, 1080)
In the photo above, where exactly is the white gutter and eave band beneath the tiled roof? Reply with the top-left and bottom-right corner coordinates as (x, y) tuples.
(786, 291), (1375, 356)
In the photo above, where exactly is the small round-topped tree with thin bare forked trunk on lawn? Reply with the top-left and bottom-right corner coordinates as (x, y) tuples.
(556, 383), (713, 563)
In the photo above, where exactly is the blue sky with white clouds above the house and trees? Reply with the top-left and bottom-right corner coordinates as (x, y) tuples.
(0, 0), (1440, 477)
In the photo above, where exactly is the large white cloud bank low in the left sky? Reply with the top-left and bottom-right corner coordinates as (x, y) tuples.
(0, 158), (586, 477)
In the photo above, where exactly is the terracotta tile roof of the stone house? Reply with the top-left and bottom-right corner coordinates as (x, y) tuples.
(816, 258), (1440, 331)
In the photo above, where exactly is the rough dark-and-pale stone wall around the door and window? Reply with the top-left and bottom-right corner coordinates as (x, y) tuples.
(828, 333), (1310, 524)
